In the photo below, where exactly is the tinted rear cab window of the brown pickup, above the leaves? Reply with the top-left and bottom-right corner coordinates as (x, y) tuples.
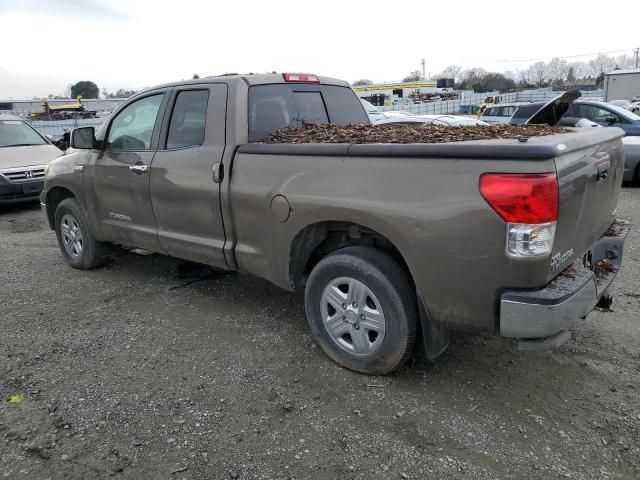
(249, 84), (370, 142)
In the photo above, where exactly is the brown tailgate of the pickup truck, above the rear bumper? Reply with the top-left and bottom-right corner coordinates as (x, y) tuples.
(549, 128), (624, 280)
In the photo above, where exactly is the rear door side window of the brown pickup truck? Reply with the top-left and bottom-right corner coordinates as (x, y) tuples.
(167, 90), (209, 149)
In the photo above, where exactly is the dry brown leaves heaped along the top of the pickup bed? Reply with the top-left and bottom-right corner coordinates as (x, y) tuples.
(267, 124), (567, 143)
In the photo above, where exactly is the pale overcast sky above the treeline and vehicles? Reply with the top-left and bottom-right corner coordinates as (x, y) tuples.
(0, 0), (640, 99)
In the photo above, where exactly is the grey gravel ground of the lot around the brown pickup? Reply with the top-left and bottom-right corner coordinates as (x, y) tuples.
(0, 188), (640, 480)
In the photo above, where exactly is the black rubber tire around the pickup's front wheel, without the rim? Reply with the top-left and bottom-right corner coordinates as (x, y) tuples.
(54, 198), (105, 270)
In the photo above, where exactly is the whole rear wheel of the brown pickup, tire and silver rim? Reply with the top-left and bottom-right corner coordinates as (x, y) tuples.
(305, 247), (418, 374)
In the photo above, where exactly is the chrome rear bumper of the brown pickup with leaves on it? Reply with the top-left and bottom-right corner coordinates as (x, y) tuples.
(500, 220), (629, 338)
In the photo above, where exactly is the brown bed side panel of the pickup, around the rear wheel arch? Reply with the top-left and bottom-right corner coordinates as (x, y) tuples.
(230, 146), (555, 331)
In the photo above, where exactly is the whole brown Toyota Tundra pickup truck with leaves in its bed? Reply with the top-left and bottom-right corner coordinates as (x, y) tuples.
(41, 74), (628, 373)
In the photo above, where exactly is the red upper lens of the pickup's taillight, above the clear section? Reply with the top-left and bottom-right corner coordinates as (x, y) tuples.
(480, 173), (558, 224)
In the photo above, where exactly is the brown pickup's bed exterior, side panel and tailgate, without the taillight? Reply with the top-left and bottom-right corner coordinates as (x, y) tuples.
(235, 128), (623, 331)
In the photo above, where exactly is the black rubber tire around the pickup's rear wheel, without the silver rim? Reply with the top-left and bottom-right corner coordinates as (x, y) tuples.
(305, 246), (419, 374)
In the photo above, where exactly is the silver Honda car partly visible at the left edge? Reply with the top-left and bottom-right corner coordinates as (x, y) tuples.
(0, 114), (62, 205)
